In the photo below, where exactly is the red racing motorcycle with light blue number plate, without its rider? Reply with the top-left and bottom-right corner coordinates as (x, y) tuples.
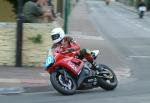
(45, 50), (118, 95)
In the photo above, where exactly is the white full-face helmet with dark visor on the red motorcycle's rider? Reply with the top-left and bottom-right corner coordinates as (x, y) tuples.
(51, 28), (65, 43)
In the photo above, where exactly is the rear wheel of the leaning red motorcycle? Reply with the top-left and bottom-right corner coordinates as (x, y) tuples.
(98, 64), (118, 90)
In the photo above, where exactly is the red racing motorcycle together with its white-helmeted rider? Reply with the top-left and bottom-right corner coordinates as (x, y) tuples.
(44, 28), (118, 95)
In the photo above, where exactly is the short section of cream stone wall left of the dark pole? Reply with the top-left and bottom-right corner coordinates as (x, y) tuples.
(0, 23), (16, 65)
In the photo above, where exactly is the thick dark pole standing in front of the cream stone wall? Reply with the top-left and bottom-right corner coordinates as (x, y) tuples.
(16, 0), (23, 67)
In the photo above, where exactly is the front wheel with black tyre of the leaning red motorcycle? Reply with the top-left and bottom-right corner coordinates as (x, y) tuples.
(50, 69), (77, 95)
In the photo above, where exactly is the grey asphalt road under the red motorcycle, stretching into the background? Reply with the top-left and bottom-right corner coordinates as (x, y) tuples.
(0, 0), (150, 103)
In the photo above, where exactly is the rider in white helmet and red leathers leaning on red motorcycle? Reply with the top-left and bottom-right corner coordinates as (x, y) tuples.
(50, 28), (93, 63)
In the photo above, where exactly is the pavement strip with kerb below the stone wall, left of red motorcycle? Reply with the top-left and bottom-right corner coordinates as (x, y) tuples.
(0, 66), (53, 94)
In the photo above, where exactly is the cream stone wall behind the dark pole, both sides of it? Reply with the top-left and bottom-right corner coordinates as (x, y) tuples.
(0, 22), (59, 67)
